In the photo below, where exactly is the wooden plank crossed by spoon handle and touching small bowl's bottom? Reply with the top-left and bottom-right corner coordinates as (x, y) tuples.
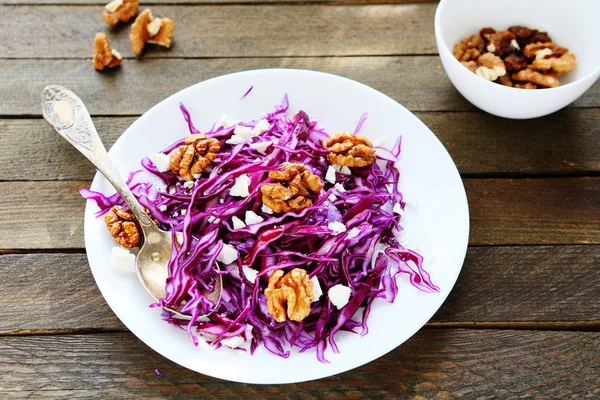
(0, 108), (600, 180)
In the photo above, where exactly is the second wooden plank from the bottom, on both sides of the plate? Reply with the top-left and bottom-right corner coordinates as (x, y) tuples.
(0, 246), (600, 335)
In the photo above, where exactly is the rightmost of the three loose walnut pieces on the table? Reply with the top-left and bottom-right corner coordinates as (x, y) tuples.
(129, 8), (175, 56)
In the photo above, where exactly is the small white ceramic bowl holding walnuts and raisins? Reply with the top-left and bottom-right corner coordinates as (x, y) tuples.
(435, 0), (600, 119)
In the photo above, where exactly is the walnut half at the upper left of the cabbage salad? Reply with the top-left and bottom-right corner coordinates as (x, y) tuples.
(170, 133), (221, 181)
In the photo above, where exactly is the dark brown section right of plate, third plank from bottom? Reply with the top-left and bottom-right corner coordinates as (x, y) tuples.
(464, 177), (600, 245)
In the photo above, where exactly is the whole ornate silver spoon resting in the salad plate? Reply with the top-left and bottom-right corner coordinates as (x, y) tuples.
(42, 85), (222, 319)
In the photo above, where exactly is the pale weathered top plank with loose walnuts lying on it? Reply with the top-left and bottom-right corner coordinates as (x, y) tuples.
(0, 4), (436, 58)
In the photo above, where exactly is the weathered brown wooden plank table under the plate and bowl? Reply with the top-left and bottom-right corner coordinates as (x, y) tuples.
(0, 0), (600, 399)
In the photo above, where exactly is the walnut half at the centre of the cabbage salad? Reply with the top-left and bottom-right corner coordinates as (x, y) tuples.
(260, 163), (323, 214)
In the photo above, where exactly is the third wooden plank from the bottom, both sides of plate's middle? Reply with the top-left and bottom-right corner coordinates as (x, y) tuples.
(0, 177), (600, 249)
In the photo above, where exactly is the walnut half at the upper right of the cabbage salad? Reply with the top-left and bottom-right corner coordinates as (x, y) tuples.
(323, 132), (376, 167)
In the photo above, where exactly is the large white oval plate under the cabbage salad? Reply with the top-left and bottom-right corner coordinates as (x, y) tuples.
(85, 69), (469, 384)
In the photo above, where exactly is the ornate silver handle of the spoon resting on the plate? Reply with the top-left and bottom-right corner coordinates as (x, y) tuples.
(42, 85), (158, 236)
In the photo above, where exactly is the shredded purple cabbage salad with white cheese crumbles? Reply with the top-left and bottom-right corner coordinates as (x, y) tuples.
(81, 95), (439, 363)
